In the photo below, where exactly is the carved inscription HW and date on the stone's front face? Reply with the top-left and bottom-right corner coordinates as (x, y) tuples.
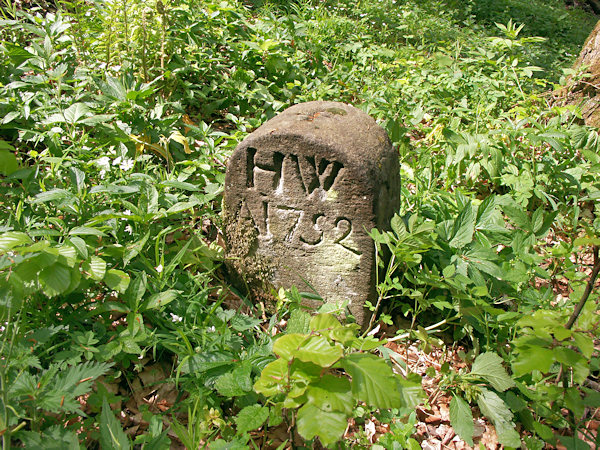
(241, 147), (361, 256)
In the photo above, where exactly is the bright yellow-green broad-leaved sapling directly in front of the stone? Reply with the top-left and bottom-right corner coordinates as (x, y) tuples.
(251, 314), (422, 447)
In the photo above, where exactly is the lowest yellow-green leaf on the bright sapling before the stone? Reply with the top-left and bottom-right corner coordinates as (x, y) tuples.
(297, 403), (348, 448)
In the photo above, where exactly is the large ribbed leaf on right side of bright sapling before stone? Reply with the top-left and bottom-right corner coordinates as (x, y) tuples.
(340, 353), (402, 409)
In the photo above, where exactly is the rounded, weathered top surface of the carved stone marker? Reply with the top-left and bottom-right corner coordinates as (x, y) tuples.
(234, 101), (397, 178)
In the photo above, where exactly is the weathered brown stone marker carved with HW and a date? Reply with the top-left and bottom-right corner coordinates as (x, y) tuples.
(224, 101), (400, 324)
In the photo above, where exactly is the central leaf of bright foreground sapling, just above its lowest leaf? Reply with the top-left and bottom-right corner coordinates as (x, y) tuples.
(306, 375), (355, 416)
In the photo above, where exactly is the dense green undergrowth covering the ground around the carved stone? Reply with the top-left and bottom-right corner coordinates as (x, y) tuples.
(0, 0), (600, 449)
